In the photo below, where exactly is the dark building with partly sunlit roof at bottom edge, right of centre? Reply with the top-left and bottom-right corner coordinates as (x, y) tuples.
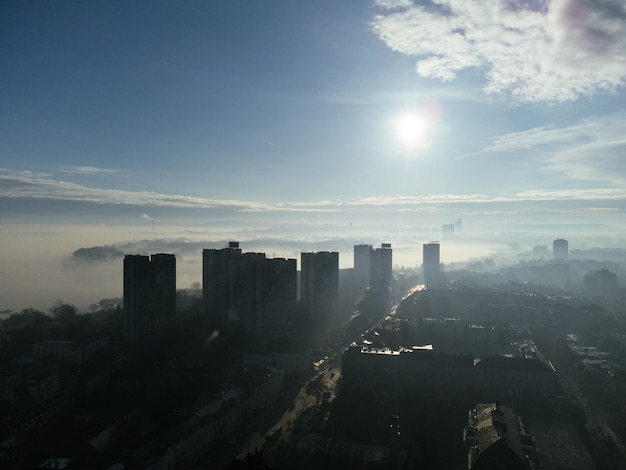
(463, 402), (537, 470)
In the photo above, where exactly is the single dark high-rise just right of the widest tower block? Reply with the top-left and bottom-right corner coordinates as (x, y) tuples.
(300, 251), (339, 320)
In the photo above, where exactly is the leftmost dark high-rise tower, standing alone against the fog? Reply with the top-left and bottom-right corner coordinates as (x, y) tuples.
(124, 253), (176, 342)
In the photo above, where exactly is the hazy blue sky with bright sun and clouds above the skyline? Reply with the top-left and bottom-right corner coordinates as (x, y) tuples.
(0, 0), (626, 310)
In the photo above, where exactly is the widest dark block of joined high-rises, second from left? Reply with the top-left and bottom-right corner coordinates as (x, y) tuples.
(202, 242), (297, 350)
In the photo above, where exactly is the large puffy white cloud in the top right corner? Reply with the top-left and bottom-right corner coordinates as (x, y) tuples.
(372, 0), (626, 102)
